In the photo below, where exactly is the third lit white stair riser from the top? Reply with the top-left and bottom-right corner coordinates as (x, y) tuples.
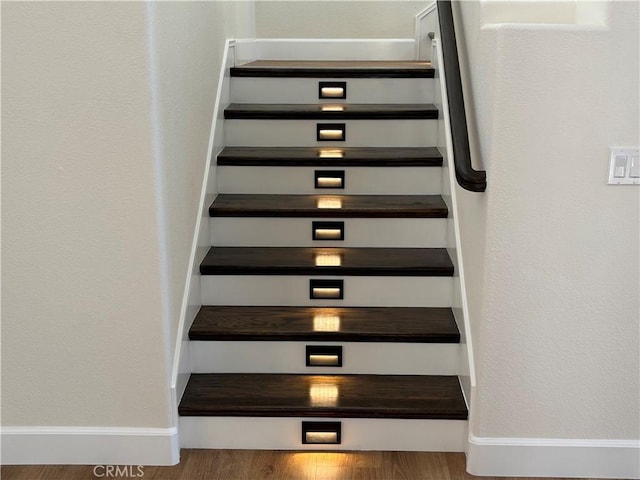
(218, 166), (442, 195)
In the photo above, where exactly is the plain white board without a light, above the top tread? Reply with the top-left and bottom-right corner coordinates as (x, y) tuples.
(235, 38), (415, 63)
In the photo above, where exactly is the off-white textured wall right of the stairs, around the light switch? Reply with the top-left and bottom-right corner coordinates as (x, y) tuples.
(457, 2), (640, 439)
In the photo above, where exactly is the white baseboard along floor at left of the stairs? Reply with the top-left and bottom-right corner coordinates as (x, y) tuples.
(0, 427), (180, 465)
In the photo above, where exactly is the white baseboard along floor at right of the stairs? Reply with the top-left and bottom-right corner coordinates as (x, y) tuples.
(467, 435), (640, 479)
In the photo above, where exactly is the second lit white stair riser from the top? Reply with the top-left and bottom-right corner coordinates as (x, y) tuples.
(225, 120), (438, 147)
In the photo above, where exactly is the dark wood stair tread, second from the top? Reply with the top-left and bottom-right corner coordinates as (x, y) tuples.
(224, 103), (438, 121)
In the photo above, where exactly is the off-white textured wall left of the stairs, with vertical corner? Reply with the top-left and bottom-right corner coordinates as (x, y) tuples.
(2, 2), (254, 442)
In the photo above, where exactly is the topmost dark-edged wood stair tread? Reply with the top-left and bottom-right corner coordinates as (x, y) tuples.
(231, 60), (434, 78)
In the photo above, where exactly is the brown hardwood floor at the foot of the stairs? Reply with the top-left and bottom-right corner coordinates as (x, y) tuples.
(0, 450), (600, 480)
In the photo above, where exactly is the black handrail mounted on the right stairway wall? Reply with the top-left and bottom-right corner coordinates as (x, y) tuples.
(437, 0), (487, 192)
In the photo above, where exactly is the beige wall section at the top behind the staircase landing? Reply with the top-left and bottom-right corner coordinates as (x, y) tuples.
(256, 0), (424, 38)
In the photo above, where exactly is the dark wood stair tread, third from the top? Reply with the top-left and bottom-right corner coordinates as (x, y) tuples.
(218, 147), (442, 167)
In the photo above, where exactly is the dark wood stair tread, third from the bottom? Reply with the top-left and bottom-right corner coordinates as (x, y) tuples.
(200, 247), (453, 277)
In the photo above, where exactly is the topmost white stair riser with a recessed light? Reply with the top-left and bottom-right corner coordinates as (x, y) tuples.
(231, 77), (434, 104)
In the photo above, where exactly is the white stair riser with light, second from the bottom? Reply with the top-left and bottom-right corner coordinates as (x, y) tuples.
(190, 341), (459, 375)
